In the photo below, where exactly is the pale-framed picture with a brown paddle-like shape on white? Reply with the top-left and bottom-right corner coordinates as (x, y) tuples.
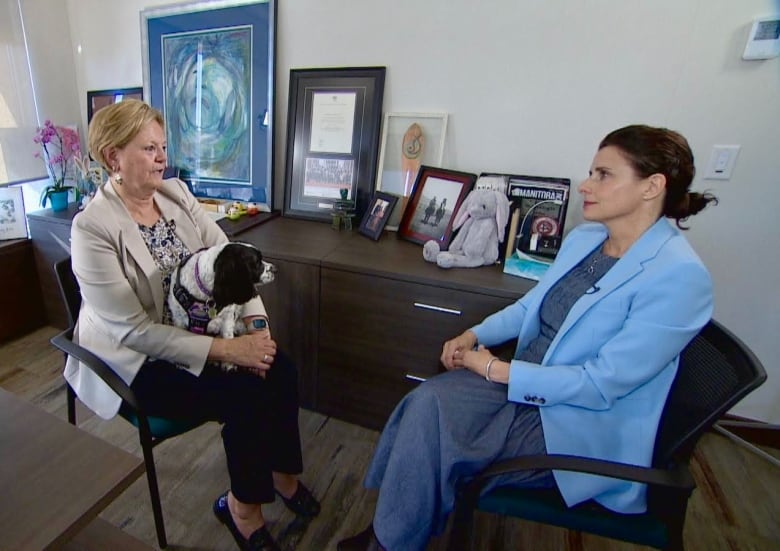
(376, 113), (447, 231)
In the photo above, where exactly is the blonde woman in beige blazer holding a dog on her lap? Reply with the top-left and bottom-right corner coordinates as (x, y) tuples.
(65, 100), (320, 550)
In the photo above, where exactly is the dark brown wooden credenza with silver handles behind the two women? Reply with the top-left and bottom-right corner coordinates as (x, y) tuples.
(29, 211), (535, 429)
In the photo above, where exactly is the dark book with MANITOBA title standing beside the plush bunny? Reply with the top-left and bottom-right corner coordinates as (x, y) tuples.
(504, 176), (571, 281)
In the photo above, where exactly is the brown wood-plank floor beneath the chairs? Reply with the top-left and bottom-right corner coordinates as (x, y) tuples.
(0, 328), (780, 551)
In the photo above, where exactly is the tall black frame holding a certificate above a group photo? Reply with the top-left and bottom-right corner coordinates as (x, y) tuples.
(284, 67), (385, 222)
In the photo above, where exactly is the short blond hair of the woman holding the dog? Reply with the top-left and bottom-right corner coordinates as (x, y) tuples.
(87, 99), (165, 174)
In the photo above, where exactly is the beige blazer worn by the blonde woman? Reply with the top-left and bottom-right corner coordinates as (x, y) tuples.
(64, 178), (265, 419)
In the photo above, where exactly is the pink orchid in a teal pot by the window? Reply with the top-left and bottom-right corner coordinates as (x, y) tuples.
(33, 120), (81, 211)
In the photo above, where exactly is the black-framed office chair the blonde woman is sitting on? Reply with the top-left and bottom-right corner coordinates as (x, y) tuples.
(51, 257), (205, 548)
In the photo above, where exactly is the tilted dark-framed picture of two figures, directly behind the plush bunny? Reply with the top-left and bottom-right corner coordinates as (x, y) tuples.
(398, 165), (477, 250)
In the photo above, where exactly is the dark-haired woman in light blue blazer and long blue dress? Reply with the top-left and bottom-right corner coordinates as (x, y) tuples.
(339, 125), (715, 551)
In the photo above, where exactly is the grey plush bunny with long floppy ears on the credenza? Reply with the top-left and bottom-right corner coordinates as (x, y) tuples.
(423, 189), (509, 268)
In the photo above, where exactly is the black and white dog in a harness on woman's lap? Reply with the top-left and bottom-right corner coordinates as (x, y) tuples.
(168, 243), (276, 370)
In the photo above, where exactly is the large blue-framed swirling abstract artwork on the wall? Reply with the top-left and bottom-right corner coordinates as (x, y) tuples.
(141, 0), (276, 205)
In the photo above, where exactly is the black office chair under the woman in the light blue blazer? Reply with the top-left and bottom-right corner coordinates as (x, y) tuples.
(449, 320), (766, 550)
